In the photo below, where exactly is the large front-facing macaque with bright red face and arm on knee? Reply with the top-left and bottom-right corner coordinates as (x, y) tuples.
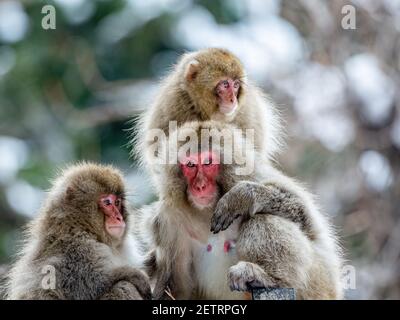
(135, 121), (342, 299)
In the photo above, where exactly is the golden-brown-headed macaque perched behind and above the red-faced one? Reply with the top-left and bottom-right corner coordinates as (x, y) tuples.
(136, 48), (281, 173)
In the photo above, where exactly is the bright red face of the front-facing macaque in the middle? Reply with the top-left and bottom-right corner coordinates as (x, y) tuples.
(180, 151), (220, 209)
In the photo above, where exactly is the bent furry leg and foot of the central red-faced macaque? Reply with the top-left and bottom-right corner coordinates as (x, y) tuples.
(233, 215), (314, 291)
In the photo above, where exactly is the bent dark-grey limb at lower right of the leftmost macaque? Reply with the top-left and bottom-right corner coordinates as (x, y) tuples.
(111, 267), (151, 300)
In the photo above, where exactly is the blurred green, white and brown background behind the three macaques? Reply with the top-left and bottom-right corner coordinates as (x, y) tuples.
(0, 0), (400, 299)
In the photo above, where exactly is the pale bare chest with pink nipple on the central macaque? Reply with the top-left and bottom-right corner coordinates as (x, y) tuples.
(193, 221), (243, 299)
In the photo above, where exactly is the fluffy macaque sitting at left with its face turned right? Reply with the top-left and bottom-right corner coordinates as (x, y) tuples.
(4, 164), (151, 300)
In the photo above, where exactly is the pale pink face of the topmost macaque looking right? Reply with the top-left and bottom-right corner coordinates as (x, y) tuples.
(216, 78), (240, 114)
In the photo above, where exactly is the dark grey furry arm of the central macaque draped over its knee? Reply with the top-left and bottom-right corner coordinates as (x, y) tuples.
(211, 181), (313, 236)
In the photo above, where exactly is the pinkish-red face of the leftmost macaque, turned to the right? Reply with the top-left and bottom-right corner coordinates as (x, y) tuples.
(99, 194), (125, 239)
